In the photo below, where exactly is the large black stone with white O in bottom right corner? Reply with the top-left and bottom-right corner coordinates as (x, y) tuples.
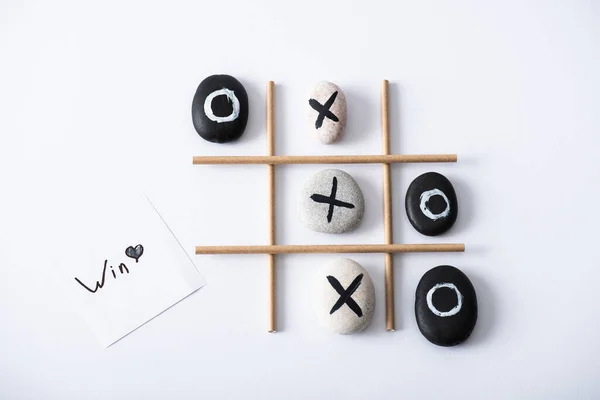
(415, 265), (477, 346)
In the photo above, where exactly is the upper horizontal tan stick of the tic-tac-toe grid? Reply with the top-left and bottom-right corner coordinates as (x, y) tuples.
(193, 154), (458, 165)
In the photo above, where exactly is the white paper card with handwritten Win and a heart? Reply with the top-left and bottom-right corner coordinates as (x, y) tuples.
(65, 195), (205, 347)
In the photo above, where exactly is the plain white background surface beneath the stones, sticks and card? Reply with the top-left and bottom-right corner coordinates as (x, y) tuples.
(0, 0), (600, 399)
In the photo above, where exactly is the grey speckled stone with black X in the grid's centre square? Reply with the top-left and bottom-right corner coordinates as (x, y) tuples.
(300, 169), (365, 233)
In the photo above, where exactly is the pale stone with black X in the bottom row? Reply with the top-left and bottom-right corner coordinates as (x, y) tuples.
(314, 258), (375, 334)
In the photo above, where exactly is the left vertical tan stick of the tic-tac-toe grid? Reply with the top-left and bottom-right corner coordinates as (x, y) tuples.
(267, 81), (277, 332)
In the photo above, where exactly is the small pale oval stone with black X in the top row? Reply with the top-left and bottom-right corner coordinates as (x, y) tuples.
(308, 82), (346, 144)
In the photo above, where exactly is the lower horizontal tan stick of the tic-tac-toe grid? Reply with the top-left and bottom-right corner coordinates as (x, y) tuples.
(196, 243), (465, 254)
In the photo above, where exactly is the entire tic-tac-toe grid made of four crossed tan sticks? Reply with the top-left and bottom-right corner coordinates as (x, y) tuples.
(193, 80), (465, 332)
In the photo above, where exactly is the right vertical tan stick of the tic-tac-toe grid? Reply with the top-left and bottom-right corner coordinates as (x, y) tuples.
(381, 80), (396, 331)
